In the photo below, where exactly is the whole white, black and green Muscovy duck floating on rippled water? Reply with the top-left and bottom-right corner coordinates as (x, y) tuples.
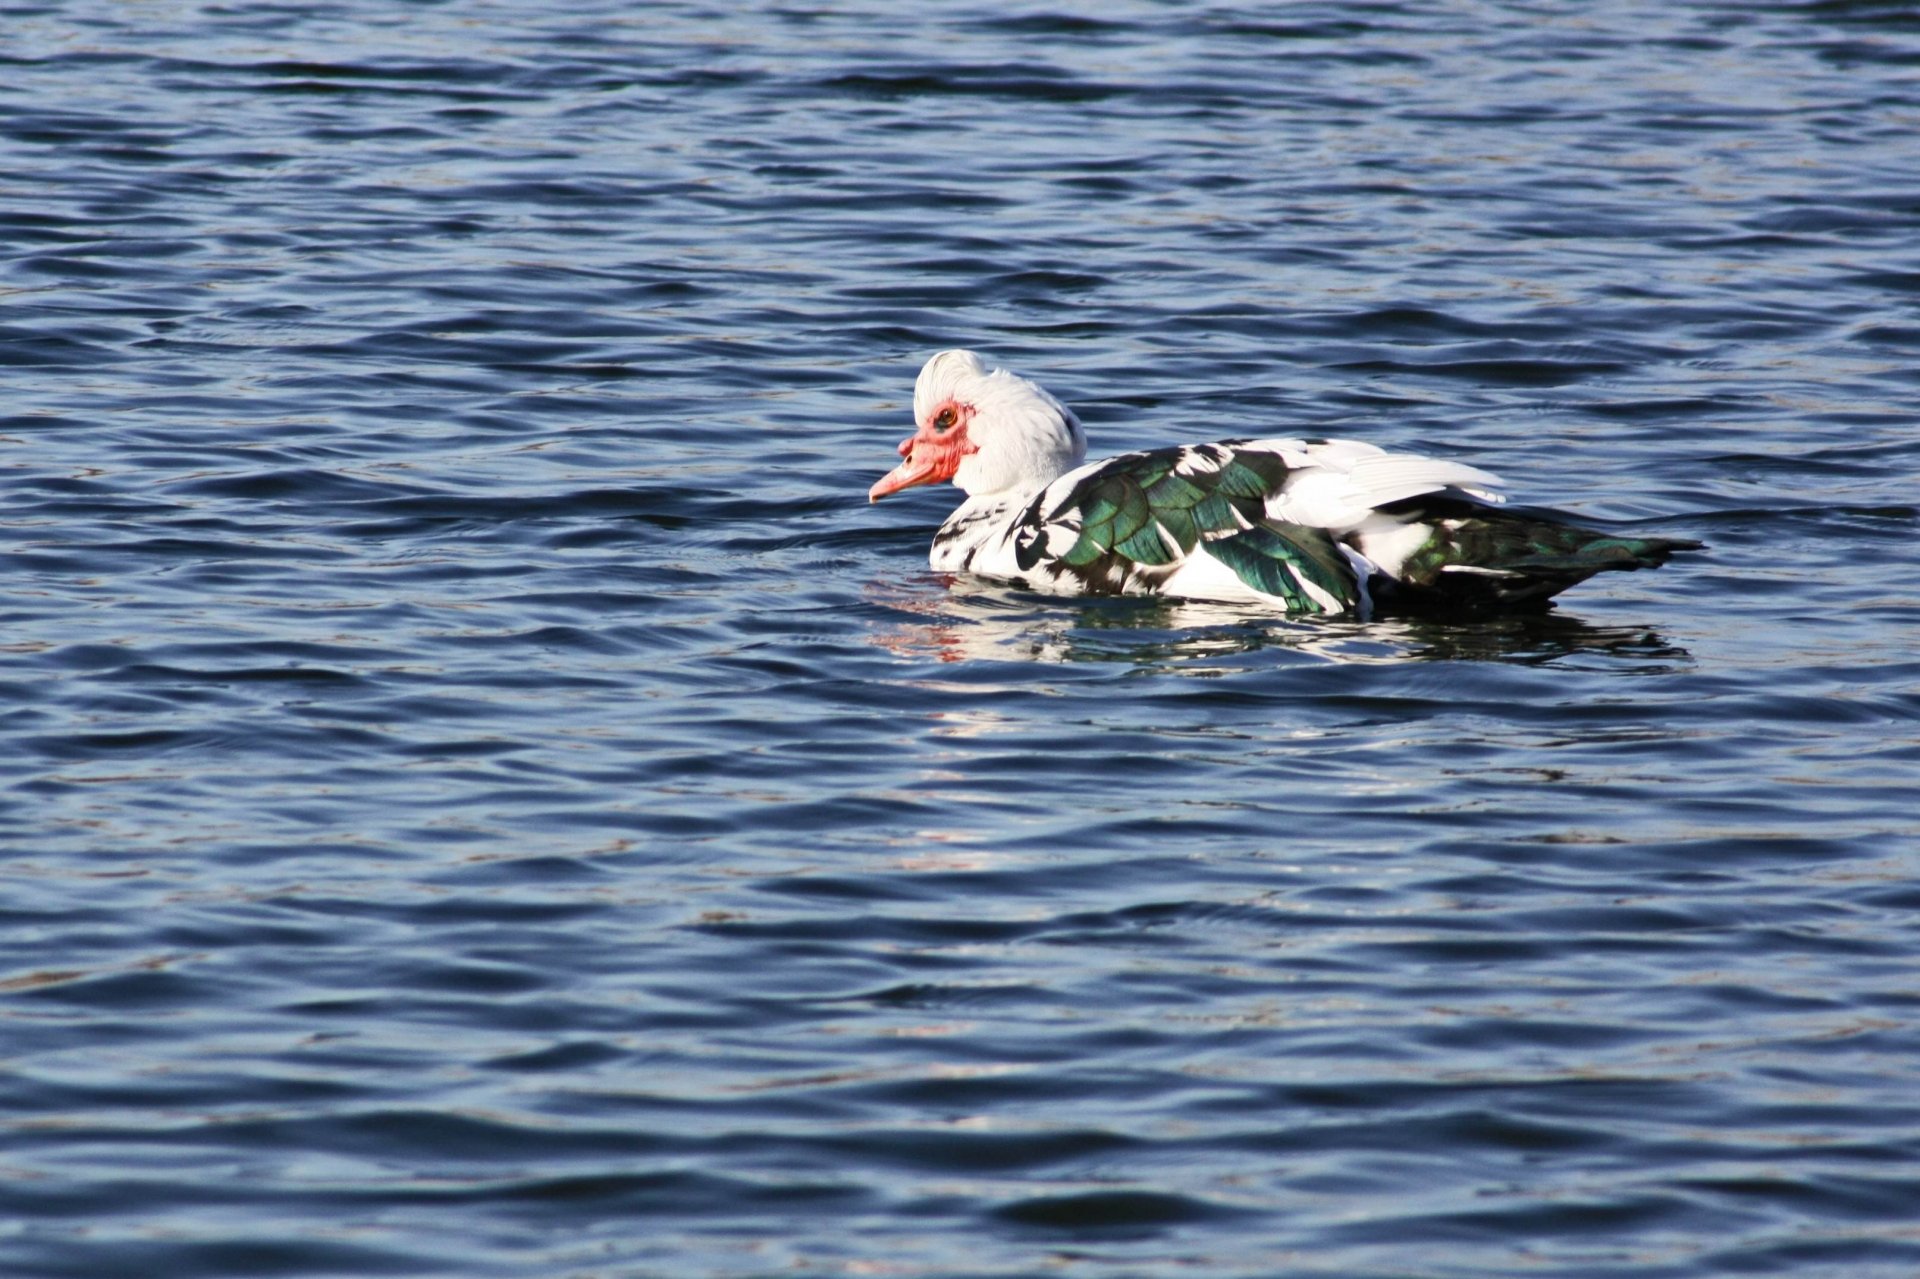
(868, 350), (1703, 618)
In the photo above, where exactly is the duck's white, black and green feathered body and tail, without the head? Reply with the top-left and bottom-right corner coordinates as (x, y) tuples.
(931, 440), (1697, 615)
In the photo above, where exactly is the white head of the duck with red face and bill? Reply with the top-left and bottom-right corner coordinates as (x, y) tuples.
(866, 351), (1087, 501)
